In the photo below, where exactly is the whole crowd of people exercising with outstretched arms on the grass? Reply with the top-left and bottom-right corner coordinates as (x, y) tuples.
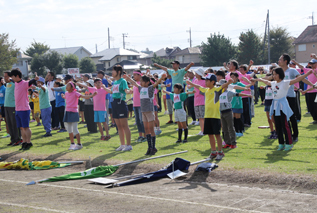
(0, 54), (317, 160)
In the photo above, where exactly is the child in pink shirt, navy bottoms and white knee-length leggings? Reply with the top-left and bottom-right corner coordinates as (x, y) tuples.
(62, 81), (97, 150)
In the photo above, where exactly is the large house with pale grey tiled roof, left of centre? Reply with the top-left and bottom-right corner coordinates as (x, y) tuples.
(90, 48), (140, 71)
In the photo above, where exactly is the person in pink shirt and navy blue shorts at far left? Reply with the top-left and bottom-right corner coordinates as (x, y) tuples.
(11, 68), (38, 150)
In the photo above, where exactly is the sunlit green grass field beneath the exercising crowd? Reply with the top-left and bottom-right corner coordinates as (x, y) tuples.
(0, 97), (317, 175)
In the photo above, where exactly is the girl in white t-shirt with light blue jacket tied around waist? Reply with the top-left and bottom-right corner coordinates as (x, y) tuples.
(252, 67), (312, 151)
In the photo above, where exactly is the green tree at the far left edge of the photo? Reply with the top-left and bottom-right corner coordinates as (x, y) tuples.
(0, 33), (20, 73)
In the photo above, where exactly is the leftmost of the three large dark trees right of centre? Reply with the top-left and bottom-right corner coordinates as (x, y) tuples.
(200, 33), (237, 66)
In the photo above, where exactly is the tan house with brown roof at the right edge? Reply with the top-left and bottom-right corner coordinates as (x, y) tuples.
(294, 25), (317, 63)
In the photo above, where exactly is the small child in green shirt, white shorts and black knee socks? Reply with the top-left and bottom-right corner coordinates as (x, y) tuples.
(163, 83), (195, 143)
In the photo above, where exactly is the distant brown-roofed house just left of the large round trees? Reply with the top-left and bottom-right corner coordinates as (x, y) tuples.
(171, 47), (201, 67)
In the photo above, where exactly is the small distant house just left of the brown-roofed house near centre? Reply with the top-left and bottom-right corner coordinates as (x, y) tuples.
(138, 47), (181, 66)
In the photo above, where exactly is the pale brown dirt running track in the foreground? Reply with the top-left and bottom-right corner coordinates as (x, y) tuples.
(0, 166), (317, 213)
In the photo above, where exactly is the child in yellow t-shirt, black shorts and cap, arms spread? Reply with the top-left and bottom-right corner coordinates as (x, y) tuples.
(186, 73), (233, 160)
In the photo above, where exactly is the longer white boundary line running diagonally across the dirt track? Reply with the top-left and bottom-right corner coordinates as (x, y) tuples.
(0, 179), (263, 213)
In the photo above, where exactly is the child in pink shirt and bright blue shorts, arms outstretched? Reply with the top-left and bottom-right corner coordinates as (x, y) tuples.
(77, 78), (111, 141)
